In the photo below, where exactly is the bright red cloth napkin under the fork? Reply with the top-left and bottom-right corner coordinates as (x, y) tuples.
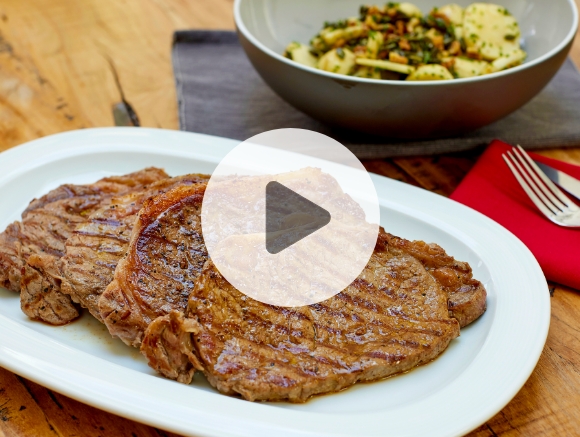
(451, 140), (580, 289)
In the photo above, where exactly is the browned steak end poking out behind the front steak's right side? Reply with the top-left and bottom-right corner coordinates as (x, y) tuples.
(386, 234), (487, 328)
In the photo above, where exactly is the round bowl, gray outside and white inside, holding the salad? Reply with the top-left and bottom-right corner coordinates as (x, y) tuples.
(234, 0), (578, 138)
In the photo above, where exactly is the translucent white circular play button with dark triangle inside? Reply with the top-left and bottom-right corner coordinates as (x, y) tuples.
(201, 129), (380, 307)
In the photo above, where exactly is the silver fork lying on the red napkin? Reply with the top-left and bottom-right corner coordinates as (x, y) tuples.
(502, 146), (580, 228)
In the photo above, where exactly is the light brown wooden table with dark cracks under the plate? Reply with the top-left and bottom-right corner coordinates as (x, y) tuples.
(0, 0), (580, 437)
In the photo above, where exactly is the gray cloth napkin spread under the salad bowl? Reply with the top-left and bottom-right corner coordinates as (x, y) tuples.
(173, 31), (580, 159)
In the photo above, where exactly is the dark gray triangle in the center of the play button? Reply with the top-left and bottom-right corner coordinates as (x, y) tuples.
(266, 181), (330, 255)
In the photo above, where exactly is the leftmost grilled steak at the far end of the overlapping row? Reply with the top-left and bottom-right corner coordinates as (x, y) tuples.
(0, 168), (168, 325)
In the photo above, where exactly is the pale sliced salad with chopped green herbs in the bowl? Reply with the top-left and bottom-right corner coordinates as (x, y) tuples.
(284, 2), (520, 80)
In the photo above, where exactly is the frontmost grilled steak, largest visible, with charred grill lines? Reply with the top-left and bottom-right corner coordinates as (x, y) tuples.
(141, 228), (459, 402)
